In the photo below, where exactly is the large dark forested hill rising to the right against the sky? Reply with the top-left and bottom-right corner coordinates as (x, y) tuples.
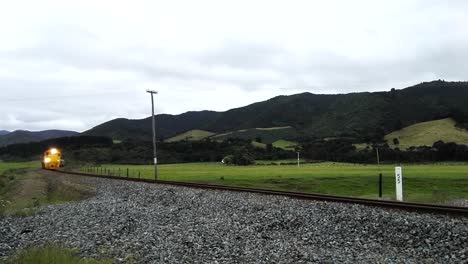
(84, 80), (468, 140)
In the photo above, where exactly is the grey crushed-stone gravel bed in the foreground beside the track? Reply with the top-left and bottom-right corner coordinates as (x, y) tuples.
(0, 174), (468, 263)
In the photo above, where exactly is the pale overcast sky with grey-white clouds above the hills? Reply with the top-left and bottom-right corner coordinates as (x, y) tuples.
(0, 0), (468, 131)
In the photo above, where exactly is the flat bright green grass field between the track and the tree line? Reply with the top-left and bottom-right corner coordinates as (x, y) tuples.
(88, 162), (468, 202)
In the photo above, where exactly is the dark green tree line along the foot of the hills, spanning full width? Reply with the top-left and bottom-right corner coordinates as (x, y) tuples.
(0, 136), (468, 165)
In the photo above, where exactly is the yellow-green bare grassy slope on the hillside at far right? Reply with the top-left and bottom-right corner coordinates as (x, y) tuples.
(385, 118), (468, 149)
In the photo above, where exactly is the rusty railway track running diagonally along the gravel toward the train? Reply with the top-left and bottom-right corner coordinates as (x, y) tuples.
(52, 170), (468, 216)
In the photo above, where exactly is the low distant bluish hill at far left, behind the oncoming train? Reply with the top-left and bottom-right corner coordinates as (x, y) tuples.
(0, 130), (78, 146)
